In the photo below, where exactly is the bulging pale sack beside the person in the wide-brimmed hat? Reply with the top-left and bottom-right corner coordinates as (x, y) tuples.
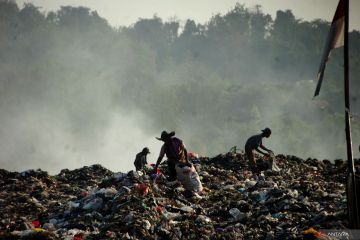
(175, 164), (203, 192)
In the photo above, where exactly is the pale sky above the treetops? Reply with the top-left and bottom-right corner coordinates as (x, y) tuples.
(16, 0), (360, 30)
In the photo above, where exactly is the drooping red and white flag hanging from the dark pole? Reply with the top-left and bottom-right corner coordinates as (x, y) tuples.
(314, 0), (345, 97)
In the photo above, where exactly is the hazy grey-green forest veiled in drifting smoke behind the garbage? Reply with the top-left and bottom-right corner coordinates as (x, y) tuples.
(0, 1), (360, 174)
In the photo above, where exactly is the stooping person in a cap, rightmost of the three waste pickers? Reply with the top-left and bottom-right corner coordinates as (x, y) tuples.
(245, 128), (272, 172)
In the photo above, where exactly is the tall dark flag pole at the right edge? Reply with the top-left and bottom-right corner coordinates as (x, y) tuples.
(344, 0), (359, 228)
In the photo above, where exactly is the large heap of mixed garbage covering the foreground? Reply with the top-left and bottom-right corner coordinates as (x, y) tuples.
(0, 153), (348, 240)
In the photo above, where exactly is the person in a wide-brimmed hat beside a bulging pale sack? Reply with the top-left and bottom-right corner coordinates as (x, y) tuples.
(155, 131), (188, 181)
